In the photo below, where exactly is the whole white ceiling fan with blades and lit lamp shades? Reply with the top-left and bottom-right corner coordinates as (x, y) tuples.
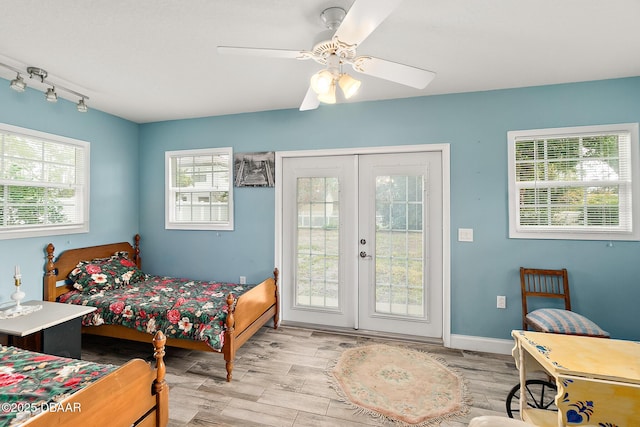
(218, 0), (435, 111)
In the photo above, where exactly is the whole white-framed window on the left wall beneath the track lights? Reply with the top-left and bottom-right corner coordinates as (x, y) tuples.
(0, 124), (89, 239)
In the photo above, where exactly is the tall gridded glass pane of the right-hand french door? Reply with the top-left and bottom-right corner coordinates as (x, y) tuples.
(375, 175), (425, 317)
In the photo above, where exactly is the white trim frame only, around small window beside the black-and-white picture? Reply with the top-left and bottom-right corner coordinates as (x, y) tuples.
(165, 147), (234, 231)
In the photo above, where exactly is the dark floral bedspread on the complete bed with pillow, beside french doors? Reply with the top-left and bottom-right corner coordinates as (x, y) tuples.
(59, 276), (256, 351)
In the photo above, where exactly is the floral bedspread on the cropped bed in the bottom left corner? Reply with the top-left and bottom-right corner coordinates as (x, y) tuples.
(0, 345), (117, 427)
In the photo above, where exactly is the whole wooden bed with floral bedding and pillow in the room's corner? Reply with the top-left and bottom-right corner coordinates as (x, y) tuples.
(44, 235), (278, 381)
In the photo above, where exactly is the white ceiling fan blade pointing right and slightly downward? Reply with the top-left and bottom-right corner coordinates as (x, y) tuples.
(350, 56), (436, 89)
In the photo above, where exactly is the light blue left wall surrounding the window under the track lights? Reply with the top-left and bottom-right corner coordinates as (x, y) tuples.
(0, 83), (139, 303)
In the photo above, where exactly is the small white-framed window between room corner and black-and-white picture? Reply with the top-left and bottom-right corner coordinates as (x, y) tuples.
(165, 147), (233, 230)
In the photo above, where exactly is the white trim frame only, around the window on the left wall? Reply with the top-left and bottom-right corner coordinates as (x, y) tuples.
(0, 123), (91, 240)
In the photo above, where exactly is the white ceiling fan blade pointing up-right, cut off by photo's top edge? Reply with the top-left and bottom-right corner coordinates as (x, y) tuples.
(334, 0), (402, 46)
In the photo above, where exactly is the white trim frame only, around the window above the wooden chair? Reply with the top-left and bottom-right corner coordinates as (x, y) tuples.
(507, 123), (640, 241)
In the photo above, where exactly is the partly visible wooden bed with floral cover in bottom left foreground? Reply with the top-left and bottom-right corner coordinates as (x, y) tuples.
(0, 332), (169, 427)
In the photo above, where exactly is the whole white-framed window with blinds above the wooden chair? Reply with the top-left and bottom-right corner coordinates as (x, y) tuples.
(507, 123), (640, 240)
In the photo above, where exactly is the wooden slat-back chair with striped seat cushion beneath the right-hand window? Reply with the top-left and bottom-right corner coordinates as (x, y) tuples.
(520, 267), (610, 338)
